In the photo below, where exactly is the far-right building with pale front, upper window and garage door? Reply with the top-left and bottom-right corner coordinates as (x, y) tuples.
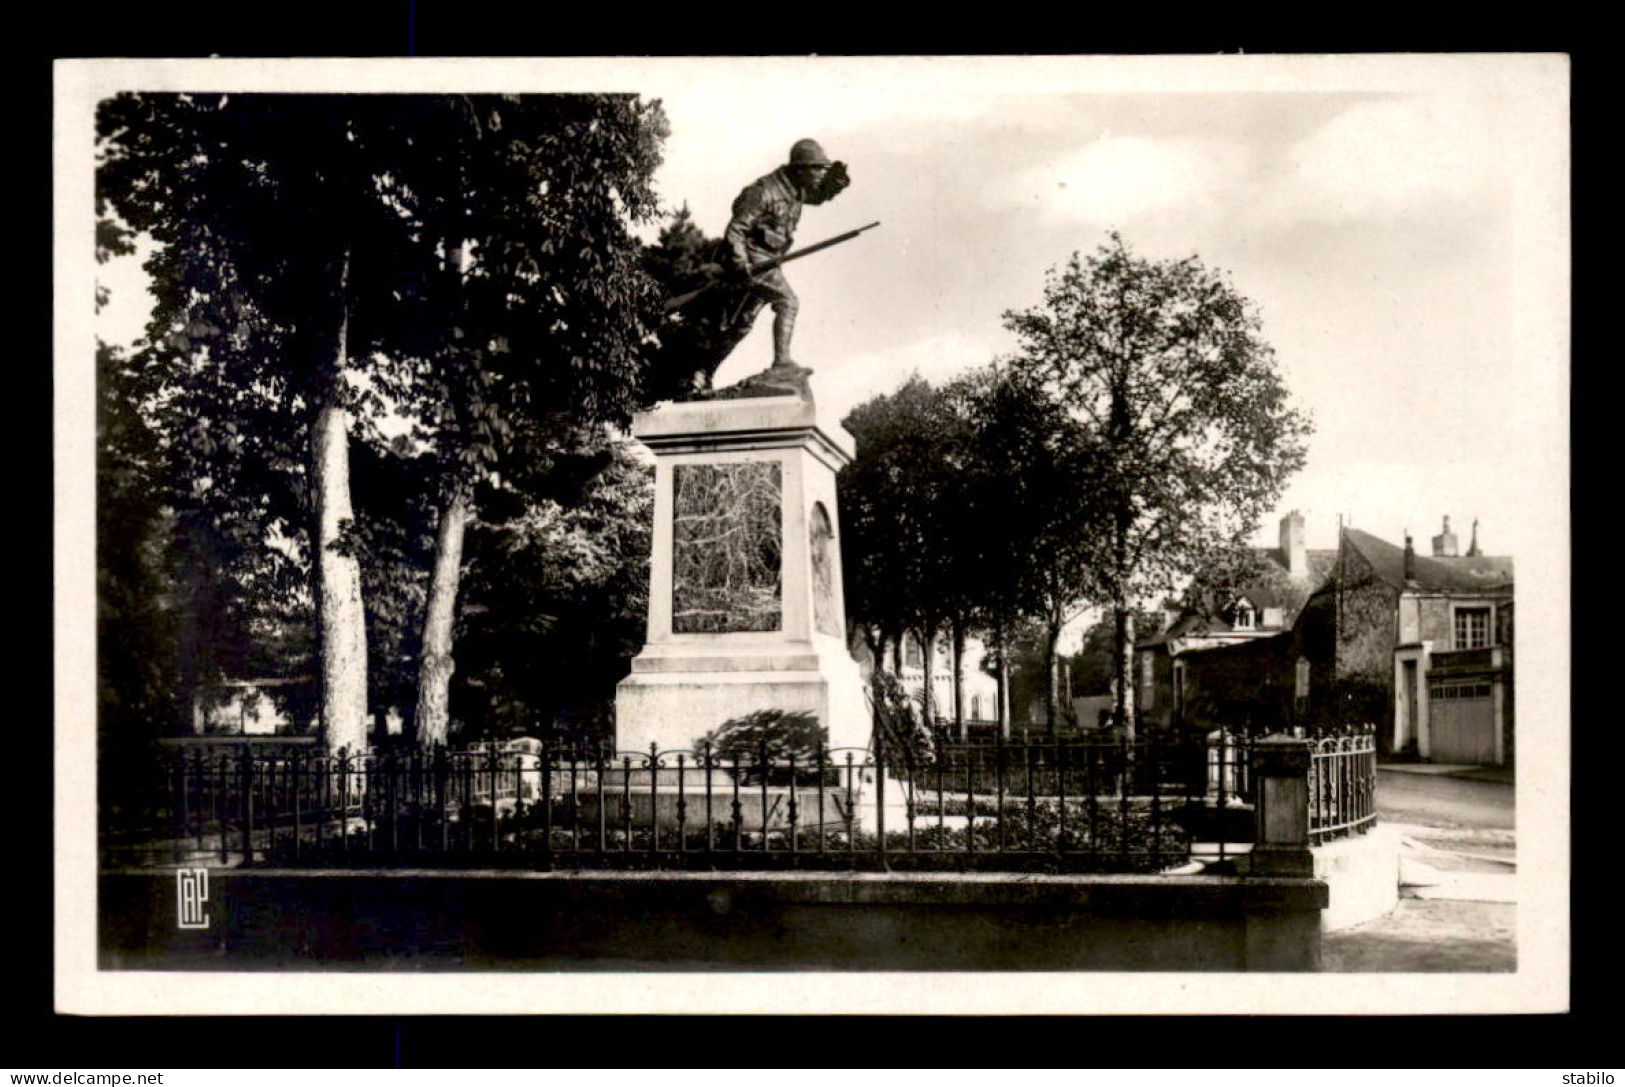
(1173, 518), (1515, 765)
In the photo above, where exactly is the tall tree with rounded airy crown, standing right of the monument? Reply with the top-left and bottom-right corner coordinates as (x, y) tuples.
(1004, 234), (1310, 734)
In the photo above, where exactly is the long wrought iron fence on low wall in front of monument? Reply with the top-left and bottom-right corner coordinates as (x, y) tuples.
(104, 727), (1251, 871)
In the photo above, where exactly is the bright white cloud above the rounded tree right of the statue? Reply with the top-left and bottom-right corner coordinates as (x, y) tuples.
(995, 133), (1245, 226)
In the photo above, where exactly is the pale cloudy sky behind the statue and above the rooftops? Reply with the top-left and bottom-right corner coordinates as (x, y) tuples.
(82, 57), (1568, 557)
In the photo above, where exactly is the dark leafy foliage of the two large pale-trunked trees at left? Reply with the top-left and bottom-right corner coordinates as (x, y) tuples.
(98, 94), (666, 747)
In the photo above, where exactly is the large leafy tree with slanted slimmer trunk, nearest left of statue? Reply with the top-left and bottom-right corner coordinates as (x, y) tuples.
(381, 94), (666, 744)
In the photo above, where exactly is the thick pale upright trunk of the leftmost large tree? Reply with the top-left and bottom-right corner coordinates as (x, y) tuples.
(312, 398), (367, 754)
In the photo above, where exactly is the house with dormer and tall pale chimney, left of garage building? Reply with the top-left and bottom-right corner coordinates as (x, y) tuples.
(1134, 510), (1337, 731)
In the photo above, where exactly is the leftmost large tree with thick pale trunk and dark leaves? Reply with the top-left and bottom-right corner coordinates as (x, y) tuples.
(98, 94), (464, 749)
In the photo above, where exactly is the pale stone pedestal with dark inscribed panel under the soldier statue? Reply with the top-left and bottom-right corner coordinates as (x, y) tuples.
(616, 392), (869, 752)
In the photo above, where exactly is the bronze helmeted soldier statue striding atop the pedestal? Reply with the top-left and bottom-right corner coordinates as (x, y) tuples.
(723, 140), (852, 383)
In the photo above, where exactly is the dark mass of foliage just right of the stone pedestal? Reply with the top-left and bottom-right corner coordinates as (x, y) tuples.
(840, 366), (1095, 720)
